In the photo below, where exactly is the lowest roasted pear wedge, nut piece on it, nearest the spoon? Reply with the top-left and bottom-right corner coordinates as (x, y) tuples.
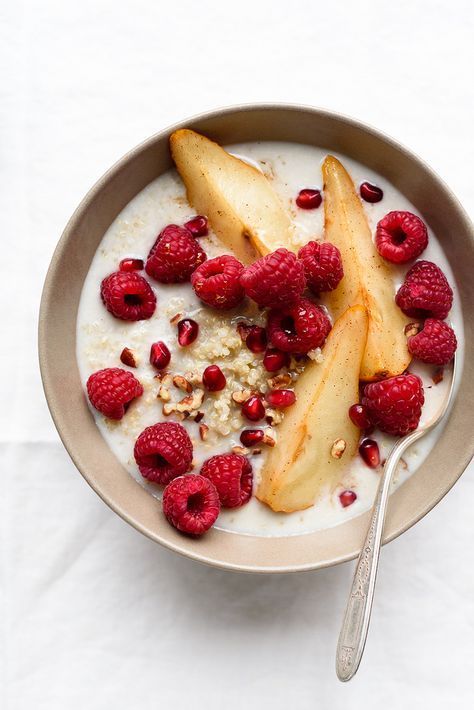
(257, 306), (368, 513)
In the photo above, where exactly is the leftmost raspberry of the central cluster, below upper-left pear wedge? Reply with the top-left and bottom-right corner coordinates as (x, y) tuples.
(191, 254), (245, 310)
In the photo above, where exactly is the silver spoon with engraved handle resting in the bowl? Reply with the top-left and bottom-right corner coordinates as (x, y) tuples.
(336, 359), (456, 682)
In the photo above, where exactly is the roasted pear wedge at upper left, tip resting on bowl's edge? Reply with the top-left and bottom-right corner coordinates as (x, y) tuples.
(170, 129), (293, 264)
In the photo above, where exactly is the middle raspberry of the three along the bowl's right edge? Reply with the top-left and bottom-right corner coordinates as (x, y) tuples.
(395, 261), (453, 320)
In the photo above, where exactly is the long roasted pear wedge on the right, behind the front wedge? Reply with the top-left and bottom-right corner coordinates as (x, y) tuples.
(323, 155), (411, 382)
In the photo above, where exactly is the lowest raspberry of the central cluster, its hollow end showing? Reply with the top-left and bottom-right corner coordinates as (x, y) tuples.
(267, 298), (331, 354)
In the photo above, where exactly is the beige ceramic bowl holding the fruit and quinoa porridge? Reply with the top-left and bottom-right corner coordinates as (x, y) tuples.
(39, 105), (474, 572)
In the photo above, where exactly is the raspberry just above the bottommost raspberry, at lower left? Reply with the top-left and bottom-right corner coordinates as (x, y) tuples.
(133, 422), (193, 483)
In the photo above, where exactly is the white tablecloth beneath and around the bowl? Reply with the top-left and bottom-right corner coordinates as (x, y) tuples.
(0, 0), (474, 710)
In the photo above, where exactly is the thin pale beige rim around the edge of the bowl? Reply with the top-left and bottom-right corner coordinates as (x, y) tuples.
(38, 102), (474, 574)
